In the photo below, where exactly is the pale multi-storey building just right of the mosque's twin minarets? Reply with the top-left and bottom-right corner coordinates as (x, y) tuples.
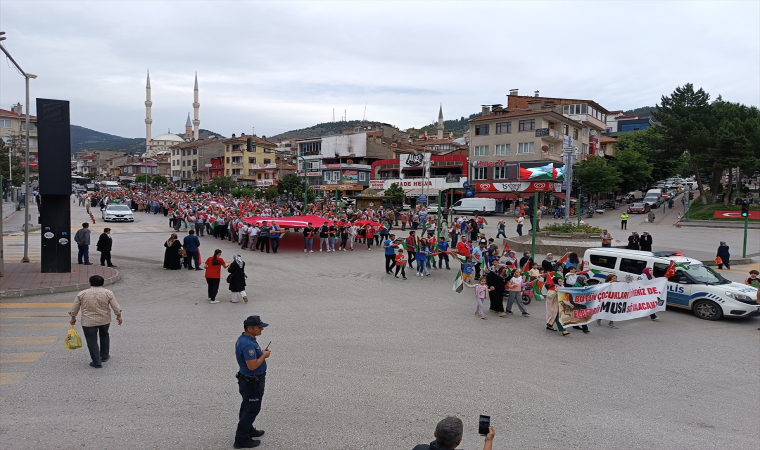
(174, 137), (225, 186)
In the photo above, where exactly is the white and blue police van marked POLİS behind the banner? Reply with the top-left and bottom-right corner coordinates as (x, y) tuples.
(583, 248), (760, 320)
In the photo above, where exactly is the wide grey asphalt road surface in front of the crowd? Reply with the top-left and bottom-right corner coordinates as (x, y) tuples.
(0, 202), (760, 449)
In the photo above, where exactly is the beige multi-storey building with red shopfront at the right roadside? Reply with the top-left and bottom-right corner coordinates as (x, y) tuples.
(469, 105), (583, 210)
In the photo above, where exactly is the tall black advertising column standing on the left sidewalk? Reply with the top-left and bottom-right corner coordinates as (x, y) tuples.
(37, 98), (73, 273)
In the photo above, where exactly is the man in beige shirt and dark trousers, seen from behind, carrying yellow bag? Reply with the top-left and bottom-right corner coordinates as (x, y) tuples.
(69, 275), (123, 369)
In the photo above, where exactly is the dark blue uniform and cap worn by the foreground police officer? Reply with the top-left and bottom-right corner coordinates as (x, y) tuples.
(235, 316), (269, 443)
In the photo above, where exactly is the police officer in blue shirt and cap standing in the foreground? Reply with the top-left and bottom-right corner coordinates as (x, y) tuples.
(234, 316), (270, 448)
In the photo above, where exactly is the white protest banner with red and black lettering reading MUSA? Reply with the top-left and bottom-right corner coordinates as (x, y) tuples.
(558, 278), (668, 327)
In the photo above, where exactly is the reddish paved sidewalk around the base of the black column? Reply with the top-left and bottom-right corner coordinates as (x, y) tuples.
(0, 262), (121, 299)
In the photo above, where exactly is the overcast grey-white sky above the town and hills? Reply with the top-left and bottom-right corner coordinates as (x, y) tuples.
(0, 0), (760, 137)
